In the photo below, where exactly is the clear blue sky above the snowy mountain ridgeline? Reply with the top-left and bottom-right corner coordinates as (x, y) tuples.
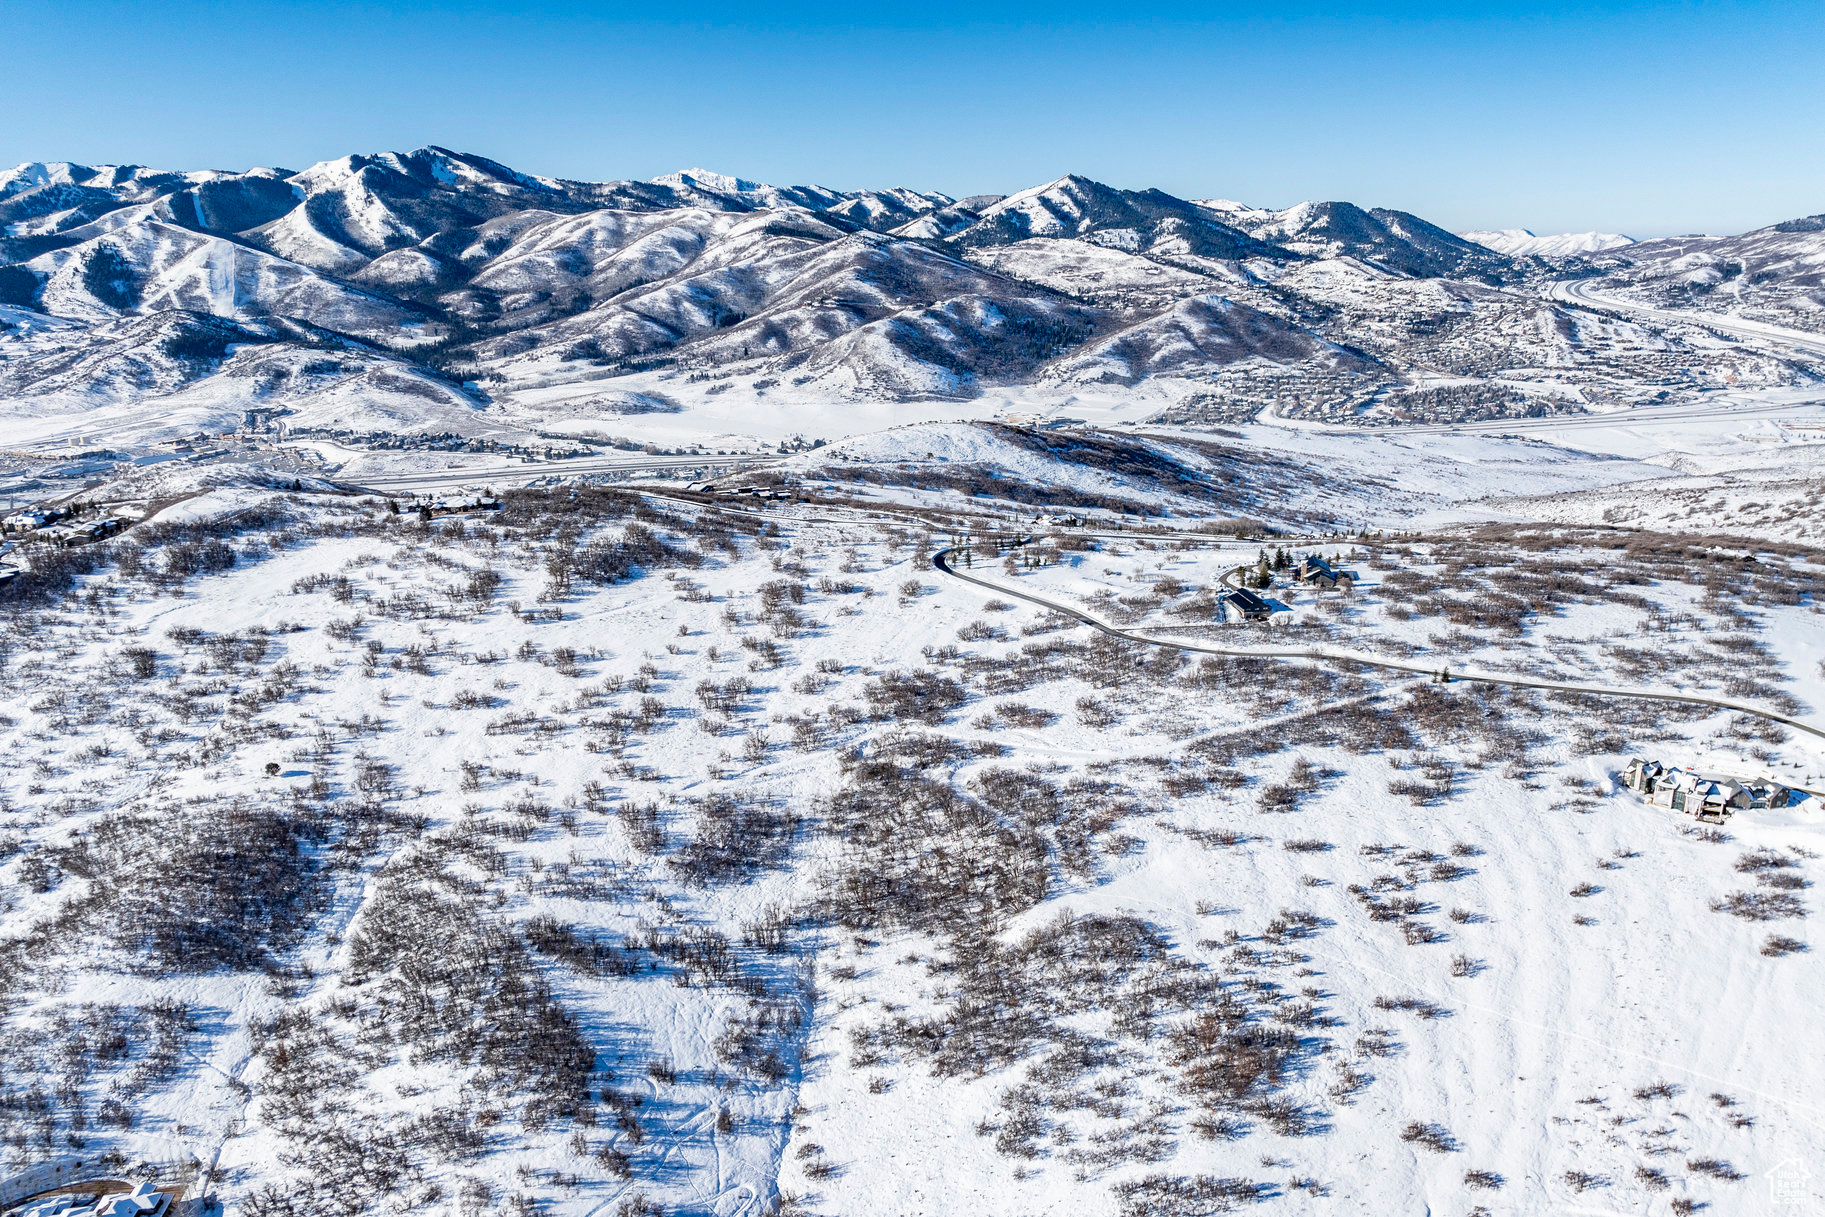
(0, 0), (1825, 235)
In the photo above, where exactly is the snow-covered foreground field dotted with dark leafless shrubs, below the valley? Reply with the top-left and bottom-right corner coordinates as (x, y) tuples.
(0, 439), (1825, 1217)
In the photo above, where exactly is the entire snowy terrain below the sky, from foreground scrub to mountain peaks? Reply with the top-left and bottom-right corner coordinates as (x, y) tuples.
(0, 137), (1825, 1217)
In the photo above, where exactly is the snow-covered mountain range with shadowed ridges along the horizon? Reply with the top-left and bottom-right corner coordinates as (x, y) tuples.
(0, 148), (1821, 450)
